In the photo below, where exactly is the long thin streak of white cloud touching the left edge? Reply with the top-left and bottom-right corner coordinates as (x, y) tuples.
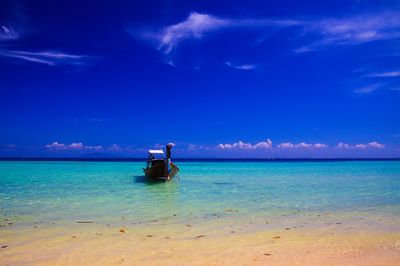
(0, 49), (91, 66)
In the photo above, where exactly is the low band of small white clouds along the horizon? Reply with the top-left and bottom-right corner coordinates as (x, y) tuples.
(0, 139), (394, 158)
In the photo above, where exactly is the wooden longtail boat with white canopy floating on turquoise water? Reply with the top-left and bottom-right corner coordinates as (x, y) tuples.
(143, 144), (179, 181)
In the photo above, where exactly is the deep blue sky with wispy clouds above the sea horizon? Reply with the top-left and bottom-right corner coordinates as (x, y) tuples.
(0, 0), (400, 158)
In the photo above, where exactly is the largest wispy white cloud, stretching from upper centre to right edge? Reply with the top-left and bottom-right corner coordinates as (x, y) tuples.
(138, 12), (400, 58)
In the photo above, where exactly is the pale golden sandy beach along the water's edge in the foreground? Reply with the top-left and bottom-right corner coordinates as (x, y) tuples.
(0, 224), (400, 265)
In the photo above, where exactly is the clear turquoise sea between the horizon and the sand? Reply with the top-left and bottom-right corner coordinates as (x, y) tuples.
(0, 161), (400, 231)
